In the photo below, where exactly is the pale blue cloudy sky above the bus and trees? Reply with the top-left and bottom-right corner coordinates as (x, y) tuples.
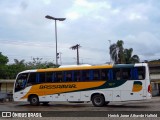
(0, 0), (160, 65)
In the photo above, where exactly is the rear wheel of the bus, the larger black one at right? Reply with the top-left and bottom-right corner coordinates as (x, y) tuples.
(92, 94), (105, 107)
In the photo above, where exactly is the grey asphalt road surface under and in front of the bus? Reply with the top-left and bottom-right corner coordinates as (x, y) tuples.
(0, 97), (160, 120)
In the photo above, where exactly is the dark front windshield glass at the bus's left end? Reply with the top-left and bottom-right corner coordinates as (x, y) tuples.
(15, 73), (28, 92)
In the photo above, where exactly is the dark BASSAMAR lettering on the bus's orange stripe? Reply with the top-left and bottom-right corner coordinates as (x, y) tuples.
(39, 84), (77, 89)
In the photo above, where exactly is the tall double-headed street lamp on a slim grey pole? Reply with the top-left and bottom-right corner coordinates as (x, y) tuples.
(45, 15), (66, 65)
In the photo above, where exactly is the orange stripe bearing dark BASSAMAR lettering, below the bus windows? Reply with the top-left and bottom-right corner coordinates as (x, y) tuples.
(21, 81), (106, 99)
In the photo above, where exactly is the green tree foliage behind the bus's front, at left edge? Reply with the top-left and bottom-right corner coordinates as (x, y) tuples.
(0, 52), (57, 79)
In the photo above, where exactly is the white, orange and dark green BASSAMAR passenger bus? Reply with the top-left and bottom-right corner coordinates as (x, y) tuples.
(13, 63), (151, 107)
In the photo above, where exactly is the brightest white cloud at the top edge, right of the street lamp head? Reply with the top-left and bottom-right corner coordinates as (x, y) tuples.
(66, 0), (111, 20)
